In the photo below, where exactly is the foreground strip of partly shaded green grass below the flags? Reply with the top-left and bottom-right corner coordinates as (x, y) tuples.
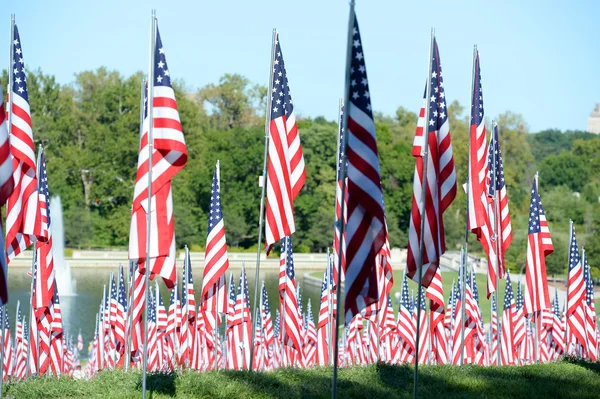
(4, 361), (600, 399)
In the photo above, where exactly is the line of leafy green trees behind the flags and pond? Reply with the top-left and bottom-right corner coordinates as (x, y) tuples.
(2, 68), (600, 274)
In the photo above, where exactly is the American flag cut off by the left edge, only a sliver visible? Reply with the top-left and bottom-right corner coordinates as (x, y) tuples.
(0, 87), (14, 306)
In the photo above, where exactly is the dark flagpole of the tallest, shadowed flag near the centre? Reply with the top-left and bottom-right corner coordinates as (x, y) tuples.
(331, 0), (355, 399)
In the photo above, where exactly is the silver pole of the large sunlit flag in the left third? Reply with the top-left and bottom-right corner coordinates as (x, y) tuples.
(142, 10), (156, 399)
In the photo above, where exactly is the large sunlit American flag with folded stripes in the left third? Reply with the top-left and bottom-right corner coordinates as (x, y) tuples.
(129, 23), (187, 288)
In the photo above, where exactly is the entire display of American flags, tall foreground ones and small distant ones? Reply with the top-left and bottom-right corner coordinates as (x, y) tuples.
(0, 6), (598, 386)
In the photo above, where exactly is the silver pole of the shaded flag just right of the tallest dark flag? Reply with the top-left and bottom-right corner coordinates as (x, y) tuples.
(413, 28), (435, 399)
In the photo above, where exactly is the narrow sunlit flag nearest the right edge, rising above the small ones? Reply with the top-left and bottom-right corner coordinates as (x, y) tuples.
(568, 221), (587, 348)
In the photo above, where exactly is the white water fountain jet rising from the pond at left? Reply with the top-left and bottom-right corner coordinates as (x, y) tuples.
(50, 196), (76, 298)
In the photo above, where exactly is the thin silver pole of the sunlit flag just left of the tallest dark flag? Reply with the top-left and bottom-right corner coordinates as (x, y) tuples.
(250, 29), (277, 371)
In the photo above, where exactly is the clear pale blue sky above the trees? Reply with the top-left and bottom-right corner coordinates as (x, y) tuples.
(0, 0), (600, 132)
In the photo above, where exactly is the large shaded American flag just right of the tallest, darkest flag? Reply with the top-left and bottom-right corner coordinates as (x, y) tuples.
(407, 38), (456, 290)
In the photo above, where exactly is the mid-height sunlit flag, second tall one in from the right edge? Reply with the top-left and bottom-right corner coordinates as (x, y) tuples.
(525, 176), (554, 314)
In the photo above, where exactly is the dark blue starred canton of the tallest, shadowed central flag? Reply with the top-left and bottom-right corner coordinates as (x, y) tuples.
(349, 15), (373, 119)
